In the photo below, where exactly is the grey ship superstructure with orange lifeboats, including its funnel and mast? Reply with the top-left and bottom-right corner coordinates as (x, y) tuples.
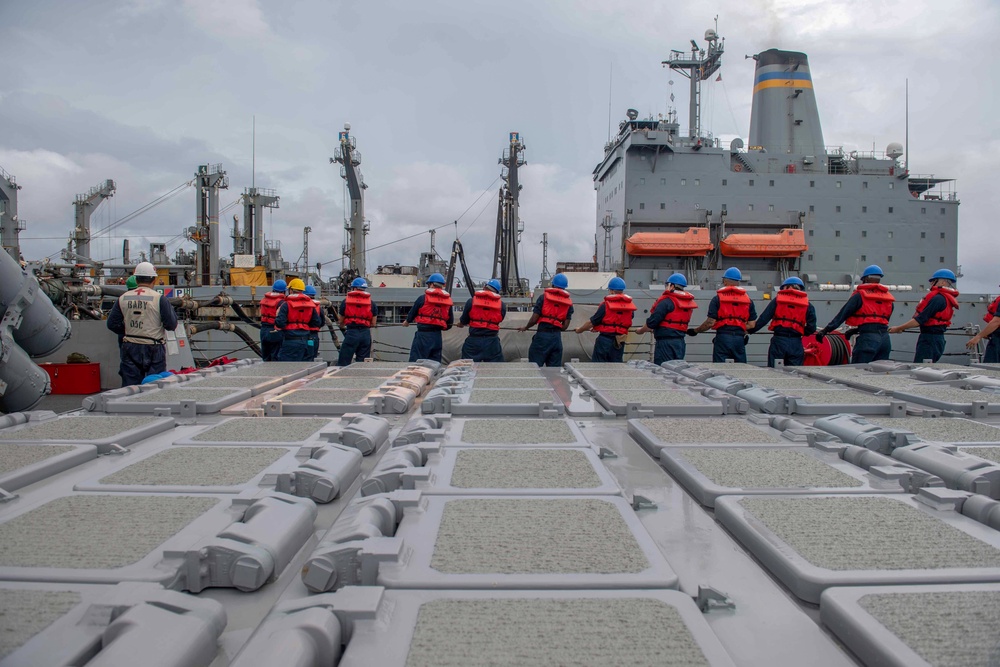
(593, 31), (959, 290)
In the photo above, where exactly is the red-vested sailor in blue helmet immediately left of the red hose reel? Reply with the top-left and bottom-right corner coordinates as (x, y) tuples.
(747, 276), (816, 368)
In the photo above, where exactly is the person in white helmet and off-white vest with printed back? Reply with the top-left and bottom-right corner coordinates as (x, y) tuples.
(107, 262), (177, 387)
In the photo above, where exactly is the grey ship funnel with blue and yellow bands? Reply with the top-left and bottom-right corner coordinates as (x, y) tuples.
(750, 49), (826, 159)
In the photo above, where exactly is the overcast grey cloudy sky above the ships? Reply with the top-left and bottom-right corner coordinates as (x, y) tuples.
(0, 0), (1000, 291)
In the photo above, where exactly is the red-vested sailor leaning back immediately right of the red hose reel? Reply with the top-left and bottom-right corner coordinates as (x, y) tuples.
(816, 264), (895, 364)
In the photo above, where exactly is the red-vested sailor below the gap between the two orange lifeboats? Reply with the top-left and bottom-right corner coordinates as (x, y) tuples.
(687, 266), (757, 364)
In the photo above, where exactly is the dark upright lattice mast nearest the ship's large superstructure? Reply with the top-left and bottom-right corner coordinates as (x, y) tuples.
(493, 132), (526, 296)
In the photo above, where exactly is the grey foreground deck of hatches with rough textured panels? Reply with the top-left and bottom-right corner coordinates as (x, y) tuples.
(0, 362), (1000, 667)
